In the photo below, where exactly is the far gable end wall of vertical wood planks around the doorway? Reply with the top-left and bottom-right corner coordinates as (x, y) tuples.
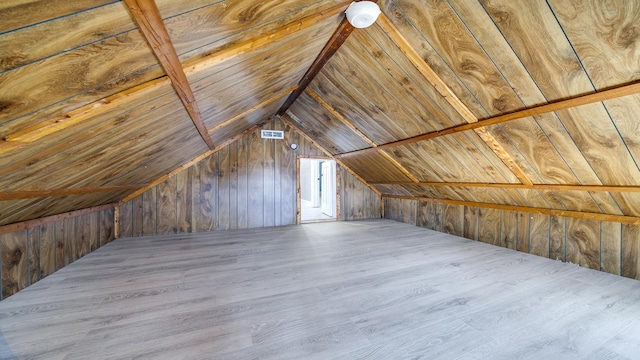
(120, 119), (380, 237)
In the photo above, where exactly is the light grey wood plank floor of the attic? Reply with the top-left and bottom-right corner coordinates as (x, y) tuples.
(0, 220), (640, 360)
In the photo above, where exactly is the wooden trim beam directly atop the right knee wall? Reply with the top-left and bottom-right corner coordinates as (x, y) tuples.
(383, 194), (640, 225)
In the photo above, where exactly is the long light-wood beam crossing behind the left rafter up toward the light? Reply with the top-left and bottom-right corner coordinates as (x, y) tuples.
(0, 2), (349, 154)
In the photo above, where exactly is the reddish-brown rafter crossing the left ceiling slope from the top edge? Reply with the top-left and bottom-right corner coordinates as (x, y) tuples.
(124, 0), (215, 149)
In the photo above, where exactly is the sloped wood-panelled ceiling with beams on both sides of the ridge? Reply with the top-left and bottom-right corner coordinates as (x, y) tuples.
(0, 0), (640, 225)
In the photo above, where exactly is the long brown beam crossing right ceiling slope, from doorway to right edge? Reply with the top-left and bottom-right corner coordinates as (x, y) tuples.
(336, 82), (640, 157)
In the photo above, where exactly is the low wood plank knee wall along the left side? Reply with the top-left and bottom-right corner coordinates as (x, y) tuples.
(0, 209), (115, 299)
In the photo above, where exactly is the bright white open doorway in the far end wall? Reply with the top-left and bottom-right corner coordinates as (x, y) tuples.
(298, 158), (337, 223)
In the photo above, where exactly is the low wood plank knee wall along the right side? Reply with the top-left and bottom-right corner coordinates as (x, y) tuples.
(384, 197), (640, 280)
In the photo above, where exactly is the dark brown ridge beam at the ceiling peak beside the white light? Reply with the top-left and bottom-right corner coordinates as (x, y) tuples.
(277, 0), (377, 116)
